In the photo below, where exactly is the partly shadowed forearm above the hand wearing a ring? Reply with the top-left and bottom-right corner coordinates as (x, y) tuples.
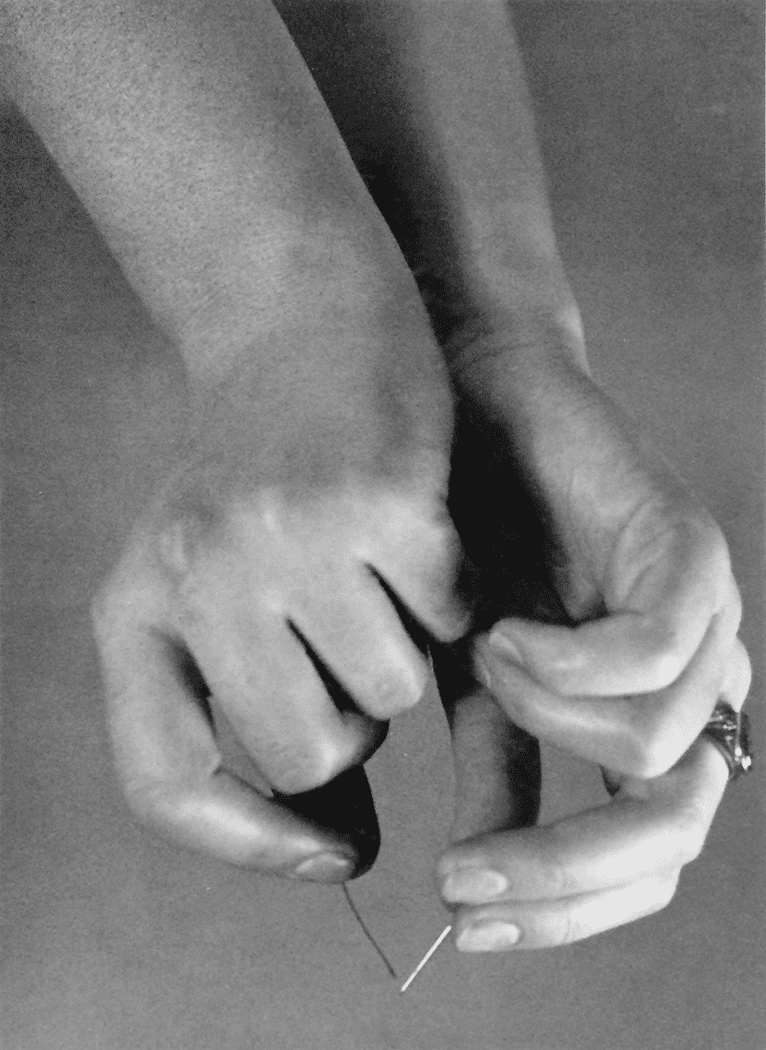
(289, 0), (584, 365)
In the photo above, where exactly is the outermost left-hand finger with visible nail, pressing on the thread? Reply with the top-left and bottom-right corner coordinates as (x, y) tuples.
(94, 579), (377, 882)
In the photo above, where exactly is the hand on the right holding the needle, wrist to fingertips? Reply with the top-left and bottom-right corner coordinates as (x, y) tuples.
(439, 359), (750, 950)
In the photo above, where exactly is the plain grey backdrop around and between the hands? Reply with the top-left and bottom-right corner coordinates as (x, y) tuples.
(0, 2), (766, 1050)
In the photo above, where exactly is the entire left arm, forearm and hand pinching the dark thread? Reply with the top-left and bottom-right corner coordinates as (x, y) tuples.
(8, 0), (466, 880)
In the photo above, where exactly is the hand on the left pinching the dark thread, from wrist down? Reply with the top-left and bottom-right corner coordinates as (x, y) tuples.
(93, 306), (467, 882)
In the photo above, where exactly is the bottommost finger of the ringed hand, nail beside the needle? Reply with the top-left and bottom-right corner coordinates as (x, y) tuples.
(453, 872), (679, 951)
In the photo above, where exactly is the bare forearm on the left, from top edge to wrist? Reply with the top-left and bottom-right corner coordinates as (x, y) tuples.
(3, 0), (417, 388)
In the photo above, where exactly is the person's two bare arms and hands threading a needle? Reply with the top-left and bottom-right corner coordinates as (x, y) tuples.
(2, 0), (750, 950)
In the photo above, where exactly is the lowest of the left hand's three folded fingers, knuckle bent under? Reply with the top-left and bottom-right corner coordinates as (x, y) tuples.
(179, 597), (381, 794)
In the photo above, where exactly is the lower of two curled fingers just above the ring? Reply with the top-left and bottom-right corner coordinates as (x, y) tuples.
(477, 614), (736, 778)
